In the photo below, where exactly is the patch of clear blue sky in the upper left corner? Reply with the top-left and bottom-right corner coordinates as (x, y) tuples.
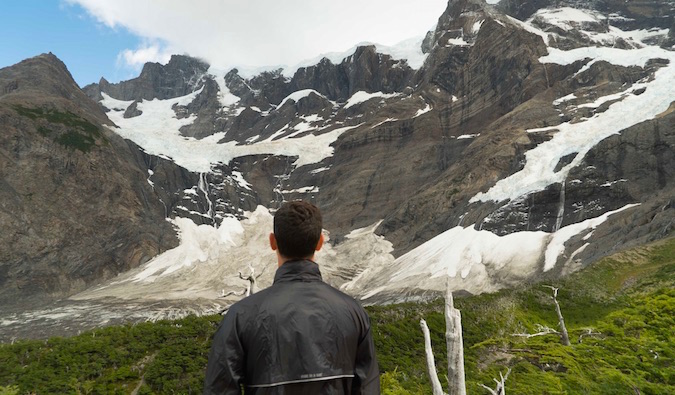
(0, 0), (140, 86)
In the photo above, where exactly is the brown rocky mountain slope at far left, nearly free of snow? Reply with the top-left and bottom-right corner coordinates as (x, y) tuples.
(0, 54), (177, 306)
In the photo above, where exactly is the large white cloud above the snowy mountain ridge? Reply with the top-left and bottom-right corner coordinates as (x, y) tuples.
(66, 0), (447, 68)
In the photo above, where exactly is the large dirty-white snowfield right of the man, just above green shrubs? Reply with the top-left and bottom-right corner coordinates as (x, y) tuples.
(352, 204), (637, 299)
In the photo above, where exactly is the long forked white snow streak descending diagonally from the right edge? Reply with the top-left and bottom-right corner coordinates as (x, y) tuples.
(471, 47), (675, 202)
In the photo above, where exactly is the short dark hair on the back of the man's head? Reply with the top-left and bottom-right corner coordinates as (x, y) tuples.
(274, 200), (323, 258)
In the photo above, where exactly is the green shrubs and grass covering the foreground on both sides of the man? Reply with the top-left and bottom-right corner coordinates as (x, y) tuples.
(0, 239), (675, 395)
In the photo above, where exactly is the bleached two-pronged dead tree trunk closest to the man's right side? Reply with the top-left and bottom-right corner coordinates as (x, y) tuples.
(420, 281), (466, 395)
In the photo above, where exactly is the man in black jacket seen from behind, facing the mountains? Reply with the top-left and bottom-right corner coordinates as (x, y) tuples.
(204, 201), (380, 395)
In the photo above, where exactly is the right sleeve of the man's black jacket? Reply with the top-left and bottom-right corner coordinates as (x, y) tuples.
(352, 312), (380, 395)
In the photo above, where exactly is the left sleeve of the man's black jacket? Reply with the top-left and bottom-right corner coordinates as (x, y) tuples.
(204, 309), (246, 395)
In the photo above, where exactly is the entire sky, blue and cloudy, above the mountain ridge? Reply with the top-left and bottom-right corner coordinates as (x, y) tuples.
(0, 0), (454, 86)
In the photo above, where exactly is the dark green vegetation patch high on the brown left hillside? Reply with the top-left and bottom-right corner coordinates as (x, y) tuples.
(13, 105), (106, 153)
